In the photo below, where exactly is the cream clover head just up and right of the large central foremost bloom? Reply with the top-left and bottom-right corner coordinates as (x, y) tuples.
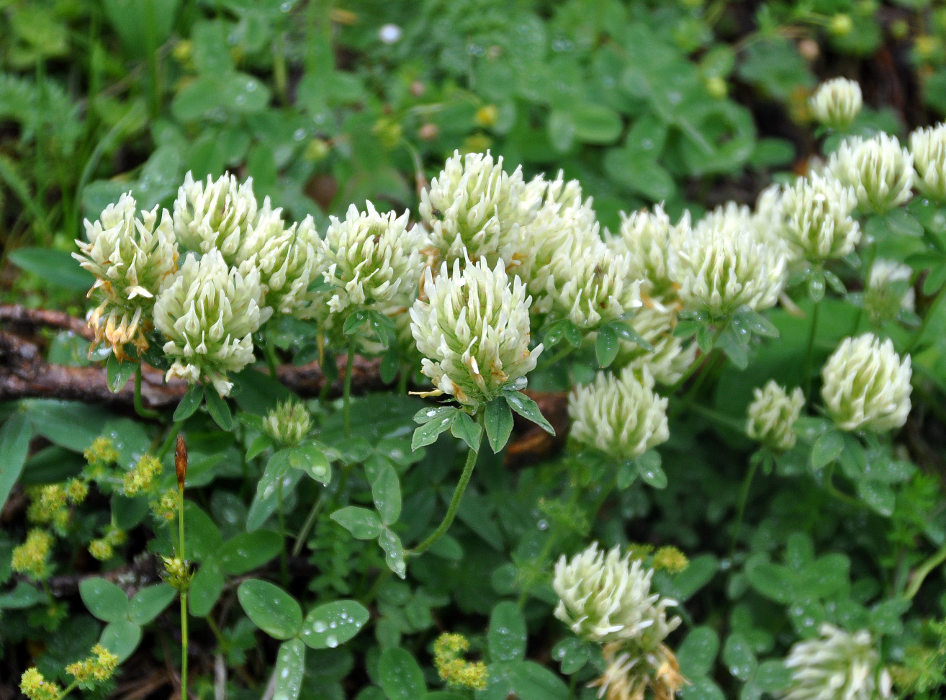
(536, 238), (643, 329)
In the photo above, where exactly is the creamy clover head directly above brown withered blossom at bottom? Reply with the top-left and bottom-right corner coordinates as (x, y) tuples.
(552, 542), (680, 653)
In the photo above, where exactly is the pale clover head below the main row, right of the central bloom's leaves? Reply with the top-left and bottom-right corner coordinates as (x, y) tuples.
(568, 365), (670, 459)
